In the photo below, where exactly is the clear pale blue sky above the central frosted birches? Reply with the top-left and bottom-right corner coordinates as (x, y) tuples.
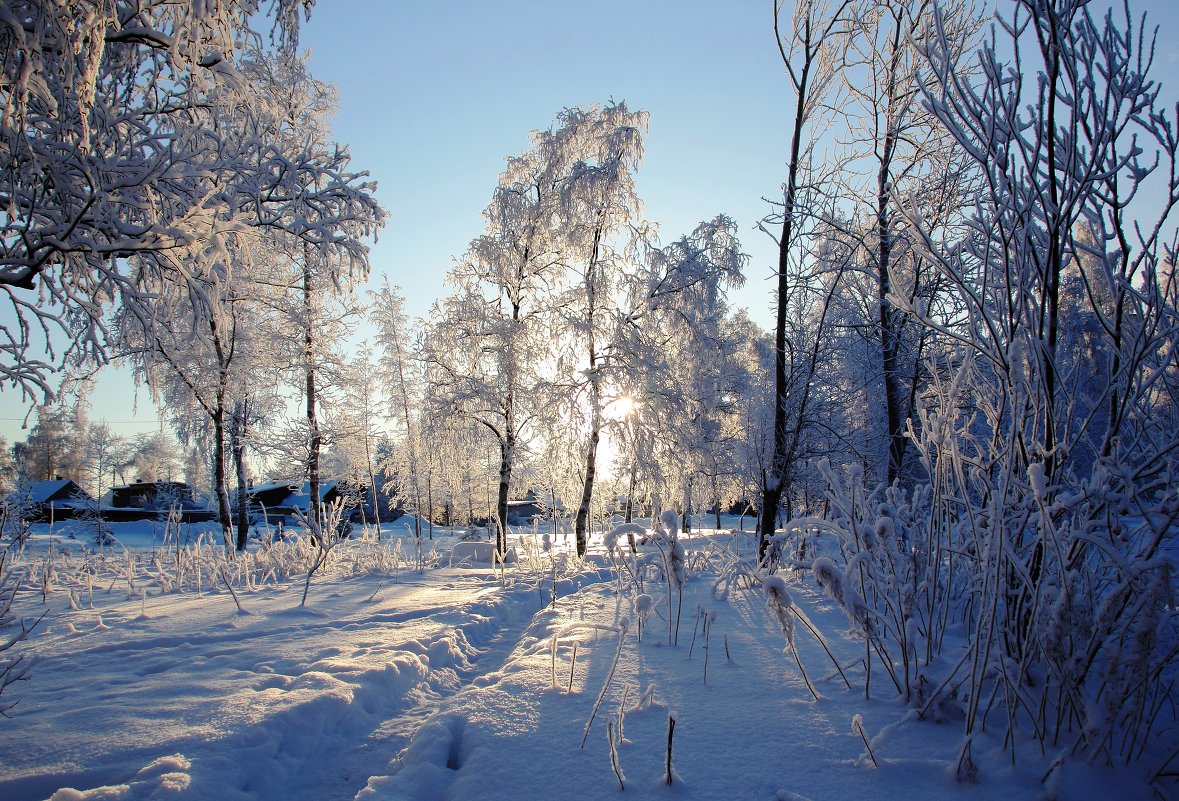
(0, 0), (1179, 441)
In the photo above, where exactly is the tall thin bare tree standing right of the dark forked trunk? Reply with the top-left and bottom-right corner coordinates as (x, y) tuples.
(841, 0), (981, 484)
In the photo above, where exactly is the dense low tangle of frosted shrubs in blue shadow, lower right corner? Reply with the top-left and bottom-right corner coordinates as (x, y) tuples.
(811, 351), (1179, 775)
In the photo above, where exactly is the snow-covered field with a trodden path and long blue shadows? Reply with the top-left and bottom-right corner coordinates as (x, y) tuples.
(0, 519), (1175, 801)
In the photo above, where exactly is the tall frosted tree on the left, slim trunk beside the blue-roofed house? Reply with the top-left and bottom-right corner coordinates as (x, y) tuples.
(221, 53), (384, 521)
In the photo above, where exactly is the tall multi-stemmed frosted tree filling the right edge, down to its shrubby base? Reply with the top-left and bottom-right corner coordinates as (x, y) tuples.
(797, 0), (1179, 779)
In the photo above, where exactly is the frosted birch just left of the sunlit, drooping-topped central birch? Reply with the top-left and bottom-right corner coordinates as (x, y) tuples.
(423, 122), (594, 553)
